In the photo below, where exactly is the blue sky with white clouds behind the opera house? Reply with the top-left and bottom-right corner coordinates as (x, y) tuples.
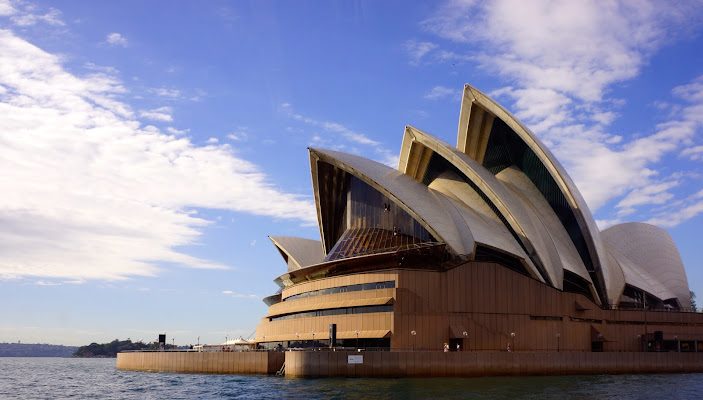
(0, 0), (703, 345)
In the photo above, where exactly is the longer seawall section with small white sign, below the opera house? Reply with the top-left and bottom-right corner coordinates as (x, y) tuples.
(285, 351), (703, 378)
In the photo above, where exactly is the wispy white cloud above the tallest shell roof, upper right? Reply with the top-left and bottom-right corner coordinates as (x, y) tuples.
(421, 0), (703, 222)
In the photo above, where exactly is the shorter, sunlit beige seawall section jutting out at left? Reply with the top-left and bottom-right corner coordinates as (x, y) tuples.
(117, 351), (284, 374)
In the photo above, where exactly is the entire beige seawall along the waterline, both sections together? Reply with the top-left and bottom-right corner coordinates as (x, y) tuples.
(117, 351), (703, 378)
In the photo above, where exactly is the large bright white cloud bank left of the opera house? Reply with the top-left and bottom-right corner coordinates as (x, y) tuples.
(0, 30), (316, 281)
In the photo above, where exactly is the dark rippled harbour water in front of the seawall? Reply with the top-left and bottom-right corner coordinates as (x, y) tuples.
(0, 358), (703, 400)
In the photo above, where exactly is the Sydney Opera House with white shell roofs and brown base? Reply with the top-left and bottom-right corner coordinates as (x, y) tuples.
(256, 85), (703, 352)
